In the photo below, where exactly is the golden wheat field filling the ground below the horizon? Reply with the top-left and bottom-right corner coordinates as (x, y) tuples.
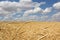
(0, 22), (60, 40)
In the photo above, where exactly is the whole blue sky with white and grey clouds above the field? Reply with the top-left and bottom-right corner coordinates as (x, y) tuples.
(0, 0), (60, 22)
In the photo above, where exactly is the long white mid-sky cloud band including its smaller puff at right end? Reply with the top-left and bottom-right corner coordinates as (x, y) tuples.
(23, 7), (52, 16)
